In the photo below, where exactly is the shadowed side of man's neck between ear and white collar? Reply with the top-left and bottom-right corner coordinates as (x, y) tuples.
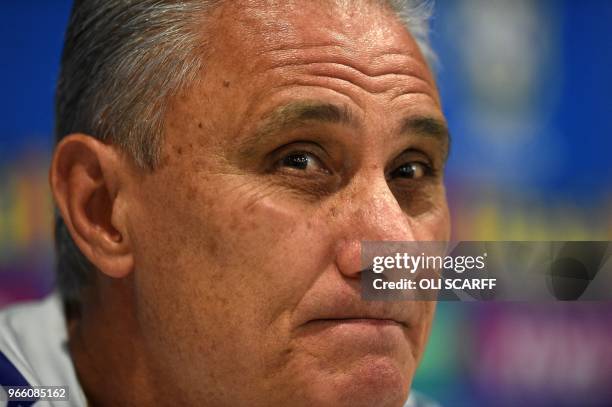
(68, 279), (158, 406)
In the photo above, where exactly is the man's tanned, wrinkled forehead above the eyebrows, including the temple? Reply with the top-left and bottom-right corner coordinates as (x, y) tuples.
(165, 0), (443, 159)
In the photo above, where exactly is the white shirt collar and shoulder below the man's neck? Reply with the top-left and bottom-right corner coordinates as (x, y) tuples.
(0, 293), (439, 407)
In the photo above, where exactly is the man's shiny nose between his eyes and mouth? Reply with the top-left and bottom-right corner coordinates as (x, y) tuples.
(335, 174), (415, 279)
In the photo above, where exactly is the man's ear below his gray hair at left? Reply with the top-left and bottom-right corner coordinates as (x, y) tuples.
(49, 134), (134, 278)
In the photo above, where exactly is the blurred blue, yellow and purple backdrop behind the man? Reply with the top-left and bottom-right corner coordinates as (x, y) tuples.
(0, 0), (612, 406)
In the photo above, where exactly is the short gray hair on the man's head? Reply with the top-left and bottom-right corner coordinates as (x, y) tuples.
(55, 0), (434, 307)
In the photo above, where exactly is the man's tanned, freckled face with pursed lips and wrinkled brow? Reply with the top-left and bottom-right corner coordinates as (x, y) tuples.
(124, 1), (449, 406)
